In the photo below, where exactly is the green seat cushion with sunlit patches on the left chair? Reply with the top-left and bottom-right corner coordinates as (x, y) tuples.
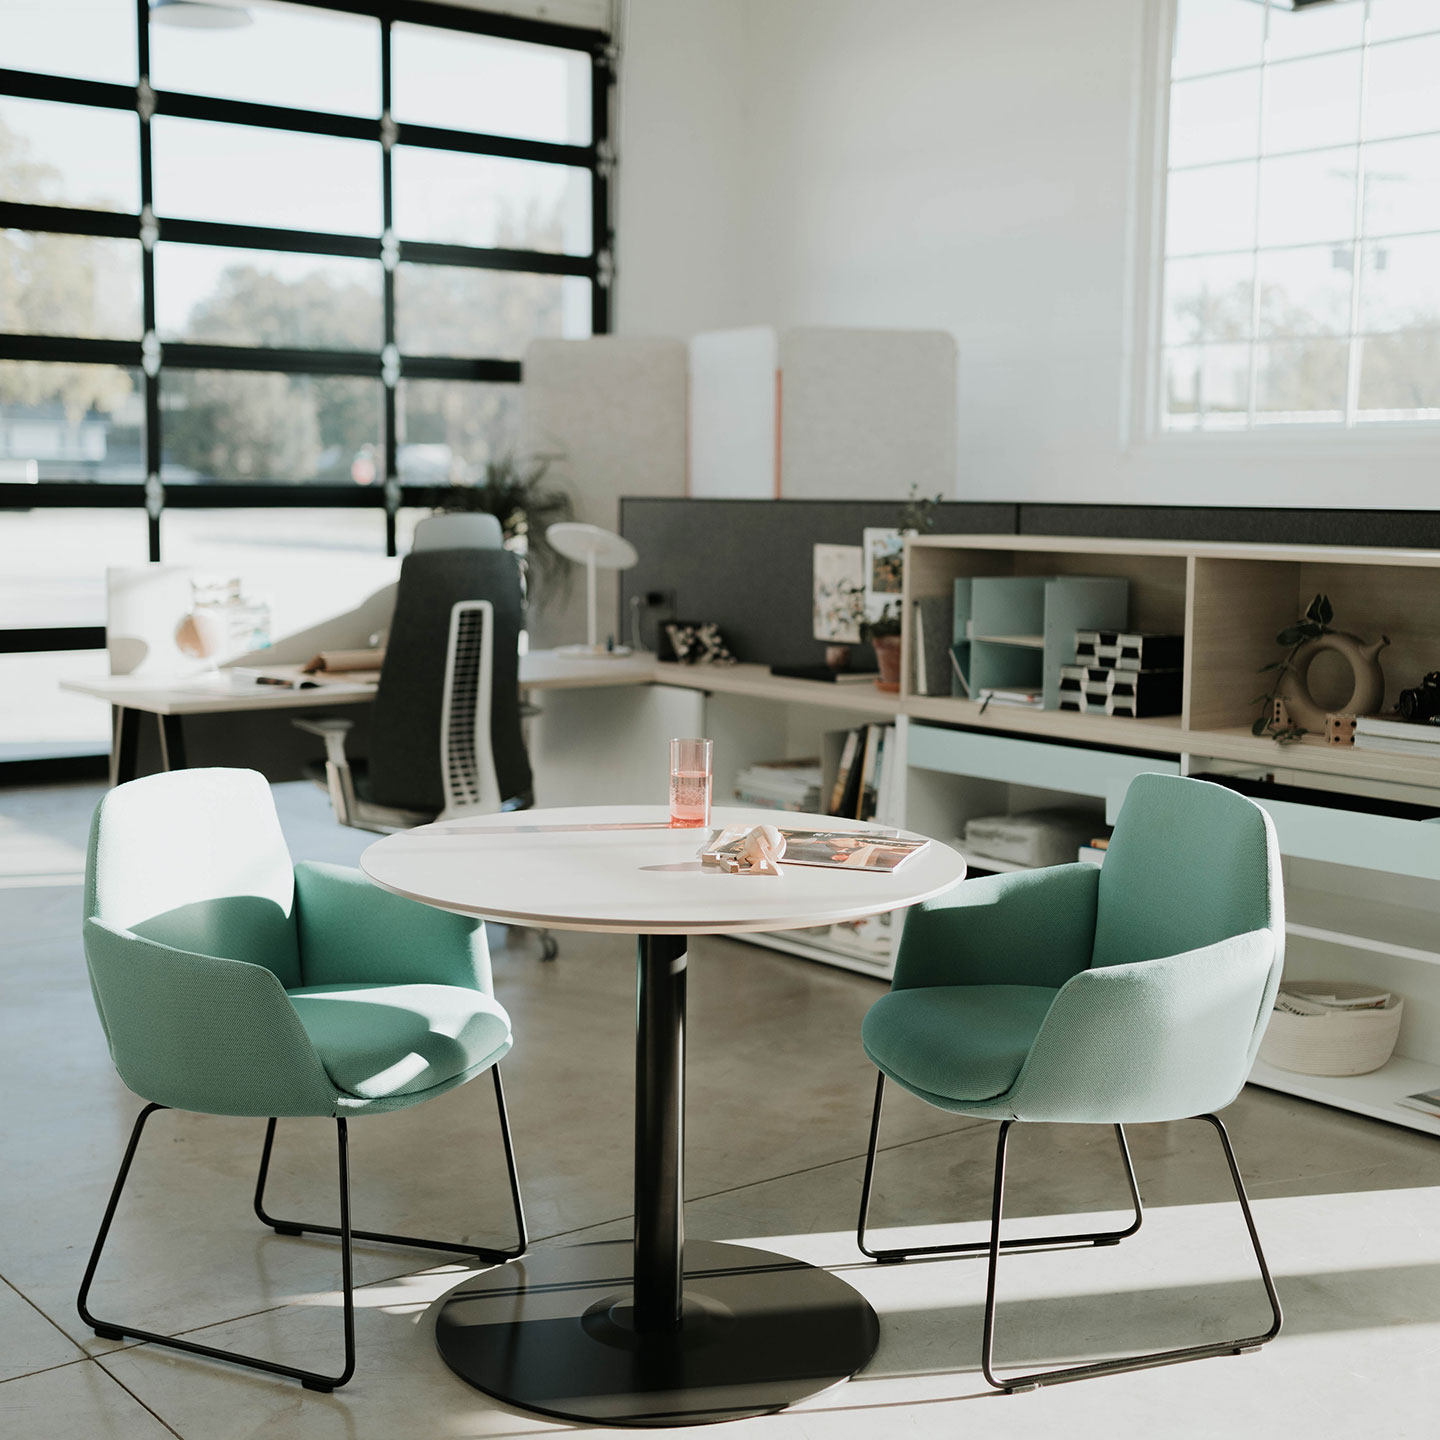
(285, 985), (510, 1100)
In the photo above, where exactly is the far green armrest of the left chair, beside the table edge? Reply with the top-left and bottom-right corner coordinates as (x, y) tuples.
(295, 860), (491, 995)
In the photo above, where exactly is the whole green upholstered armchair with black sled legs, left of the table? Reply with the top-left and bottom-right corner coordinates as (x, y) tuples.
(78, 769), (526, 1390)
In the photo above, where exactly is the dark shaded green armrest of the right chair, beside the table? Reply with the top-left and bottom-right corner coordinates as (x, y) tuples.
(893, 865), (1100, 989)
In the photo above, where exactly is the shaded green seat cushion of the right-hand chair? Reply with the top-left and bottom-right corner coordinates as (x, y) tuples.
(860, 985), (1056, 1102)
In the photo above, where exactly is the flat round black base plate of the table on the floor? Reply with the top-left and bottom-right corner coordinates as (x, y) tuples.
(435, 1240), (880, 1426)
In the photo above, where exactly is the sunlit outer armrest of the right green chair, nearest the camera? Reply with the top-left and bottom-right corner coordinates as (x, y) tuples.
(1009, 930), (1279, 1125)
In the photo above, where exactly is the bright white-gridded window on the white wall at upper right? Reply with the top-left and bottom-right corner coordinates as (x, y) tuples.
(1156, 0), (1440, 432)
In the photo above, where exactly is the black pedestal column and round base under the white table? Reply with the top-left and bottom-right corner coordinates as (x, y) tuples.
(435, 935), (880, 1426)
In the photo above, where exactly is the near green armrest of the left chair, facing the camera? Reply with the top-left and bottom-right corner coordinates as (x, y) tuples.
(85, 919), (338, 1116)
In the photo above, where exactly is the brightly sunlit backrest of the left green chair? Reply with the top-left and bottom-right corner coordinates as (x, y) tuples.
(85, 769), (300, 985)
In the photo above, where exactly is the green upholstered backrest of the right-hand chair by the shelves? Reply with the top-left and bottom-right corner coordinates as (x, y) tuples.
(1090, 775), (1284, 975)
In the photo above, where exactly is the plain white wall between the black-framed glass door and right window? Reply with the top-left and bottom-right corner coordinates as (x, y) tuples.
(618, 0), (1440, 508)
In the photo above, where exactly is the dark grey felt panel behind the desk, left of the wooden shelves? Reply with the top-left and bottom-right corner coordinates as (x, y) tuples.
(621, 497), (1015, 665)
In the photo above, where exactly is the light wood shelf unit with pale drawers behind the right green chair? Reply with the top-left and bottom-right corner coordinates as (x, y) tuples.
(900, 536), (1440, 1136)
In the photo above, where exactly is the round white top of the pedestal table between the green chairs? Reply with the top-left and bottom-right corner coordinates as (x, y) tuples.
(360, 805), (965, 935)
